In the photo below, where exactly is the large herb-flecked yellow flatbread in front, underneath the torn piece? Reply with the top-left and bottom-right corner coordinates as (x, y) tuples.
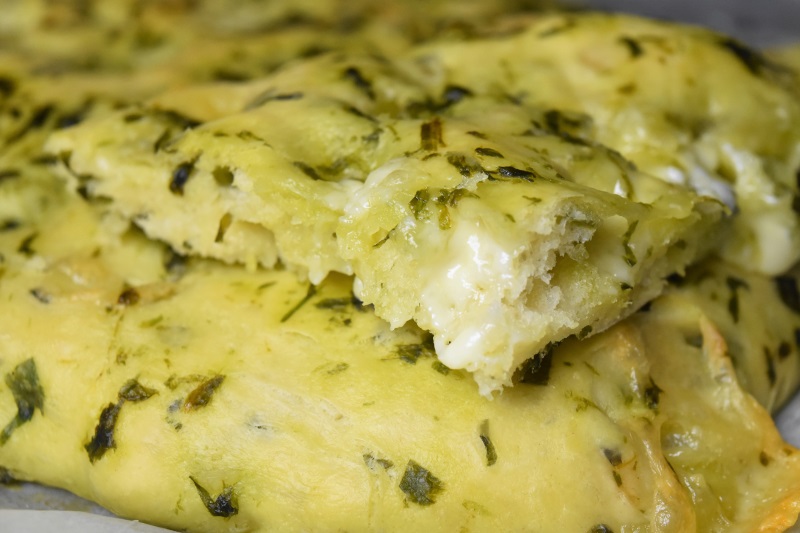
(0, 180), (800, 532)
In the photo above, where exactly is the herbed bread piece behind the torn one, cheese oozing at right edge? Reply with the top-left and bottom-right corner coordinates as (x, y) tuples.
(413, 13), (800, 275)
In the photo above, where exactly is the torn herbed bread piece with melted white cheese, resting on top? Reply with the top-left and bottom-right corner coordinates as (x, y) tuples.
(49, 52), (723, 394)
